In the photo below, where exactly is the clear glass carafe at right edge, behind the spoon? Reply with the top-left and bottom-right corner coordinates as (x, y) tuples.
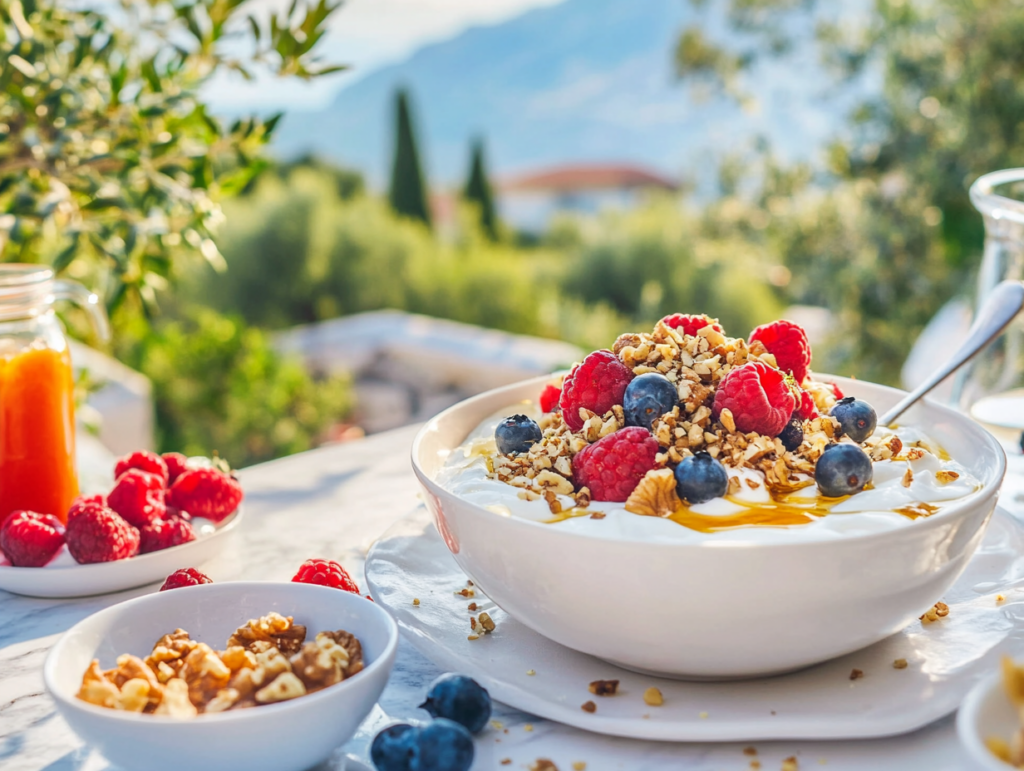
(956, 169), (1024, 443)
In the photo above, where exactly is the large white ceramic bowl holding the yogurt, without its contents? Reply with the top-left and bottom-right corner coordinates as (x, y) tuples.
(412, 376), (1006, 679)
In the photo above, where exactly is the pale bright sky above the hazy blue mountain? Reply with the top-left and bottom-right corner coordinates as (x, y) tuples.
(206, 0), (561, 111)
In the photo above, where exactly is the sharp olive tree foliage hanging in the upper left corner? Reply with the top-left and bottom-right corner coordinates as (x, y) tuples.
(0, 0), (339, 319)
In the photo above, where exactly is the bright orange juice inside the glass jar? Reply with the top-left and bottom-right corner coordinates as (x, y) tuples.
(0, 347), (78, 521)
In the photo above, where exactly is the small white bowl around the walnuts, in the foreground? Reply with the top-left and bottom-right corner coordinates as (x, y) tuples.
(43, 582), (398, 771)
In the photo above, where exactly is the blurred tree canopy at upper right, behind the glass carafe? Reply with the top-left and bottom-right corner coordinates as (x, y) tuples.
(676, 0), (1024, 382)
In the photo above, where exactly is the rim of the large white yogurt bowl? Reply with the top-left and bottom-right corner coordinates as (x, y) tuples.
(411, 373), (1007, 550)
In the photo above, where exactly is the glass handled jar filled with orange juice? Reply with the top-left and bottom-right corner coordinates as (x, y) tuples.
(0, 263), (110, 523)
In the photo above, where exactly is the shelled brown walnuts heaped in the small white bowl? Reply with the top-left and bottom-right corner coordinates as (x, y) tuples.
(78, 612), (362, 719)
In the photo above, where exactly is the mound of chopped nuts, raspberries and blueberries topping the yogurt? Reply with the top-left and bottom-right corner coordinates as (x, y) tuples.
(487, 313), (897, 516)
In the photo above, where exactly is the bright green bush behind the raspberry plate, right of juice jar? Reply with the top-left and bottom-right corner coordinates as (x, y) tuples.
(120, 309), (350, 466)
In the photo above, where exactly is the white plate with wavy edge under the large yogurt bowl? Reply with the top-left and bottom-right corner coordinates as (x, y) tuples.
(366, 509), (1024, 741)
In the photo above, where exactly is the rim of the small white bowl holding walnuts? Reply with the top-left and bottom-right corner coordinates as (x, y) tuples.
(43, 581), (398, 726)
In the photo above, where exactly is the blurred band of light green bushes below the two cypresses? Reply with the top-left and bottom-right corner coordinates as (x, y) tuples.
(193, 162), (781, 348)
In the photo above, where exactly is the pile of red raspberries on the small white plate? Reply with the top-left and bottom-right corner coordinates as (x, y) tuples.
(0, 449), (243, 567)
